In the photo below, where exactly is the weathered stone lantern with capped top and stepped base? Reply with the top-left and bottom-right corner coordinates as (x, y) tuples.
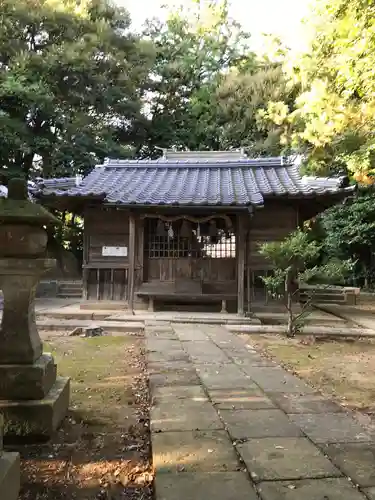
(0, 179), (69, 441)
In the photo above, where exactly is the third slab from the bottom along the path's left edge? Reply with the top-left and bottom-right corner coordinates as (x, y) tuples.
(151, 400), (224, 431)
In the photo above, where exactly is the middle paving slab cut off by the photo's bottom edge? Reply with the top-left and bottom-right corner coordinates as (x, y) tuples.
(258, 479), (365, 500)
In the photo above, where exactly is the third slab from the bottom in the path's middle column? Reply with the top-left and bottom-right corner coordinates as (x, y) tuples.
(220, 410), (302, 439)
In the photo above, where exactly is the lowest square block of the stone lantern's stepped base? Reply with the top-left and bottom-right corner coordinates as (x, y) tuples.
(0, 377), (70, 443)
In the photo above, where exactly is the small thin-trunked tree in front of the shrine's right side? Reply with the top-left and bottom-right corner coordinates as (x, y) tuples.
(259, 230), (352, 337)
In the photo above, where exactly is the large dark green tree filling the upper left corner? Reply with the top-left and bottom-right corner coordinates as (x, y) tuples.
(0, 0), (150, 177)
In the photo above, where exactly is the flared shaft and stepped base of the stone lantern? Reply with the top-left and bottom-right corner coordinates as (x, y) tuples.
(0, 258), (69, 441)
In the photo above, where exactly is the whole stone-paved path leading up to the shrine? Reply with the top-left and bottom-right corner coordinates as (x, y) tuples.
(146, 324), (375, 500)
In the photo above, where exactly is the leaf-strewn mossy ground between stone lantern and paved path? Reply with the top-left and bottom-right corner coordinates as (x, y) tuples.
(7, 334), (152, 500)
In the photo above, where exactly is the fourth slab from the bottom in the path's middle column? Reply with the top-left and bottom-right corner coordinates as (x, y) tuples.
(209, 386), (276, 410)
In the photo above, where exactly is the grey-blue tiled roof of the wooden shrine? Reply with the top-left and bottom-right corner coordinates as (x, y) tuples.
(39, 154), (352, 206)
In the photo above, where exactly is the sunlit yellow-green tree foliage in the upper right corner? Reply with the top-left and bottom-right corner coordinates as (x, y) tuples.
(260, 0), (375, 177)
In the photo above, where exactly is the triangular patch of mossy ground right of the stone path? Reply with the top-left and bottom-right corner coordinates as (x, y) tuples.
(242, 335), (375, 415)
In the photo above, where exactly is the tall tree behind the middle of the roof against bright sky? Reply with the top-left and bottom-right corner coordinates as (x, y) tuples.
(141, 0), (255, 155)
